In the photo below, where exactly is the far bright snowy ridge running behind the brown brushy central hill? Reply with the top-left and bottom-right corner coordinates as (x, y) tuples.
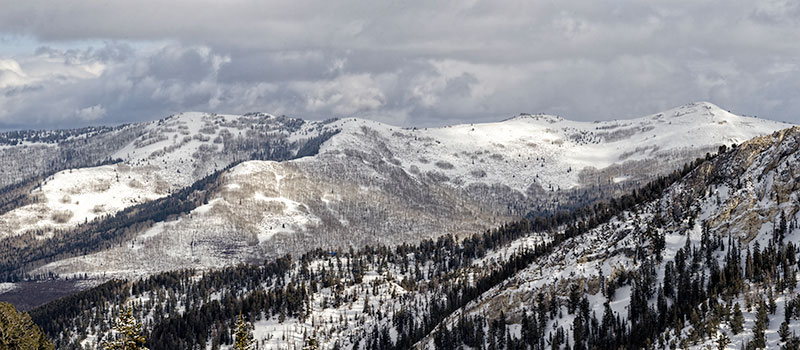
(0, 103), (787, 238)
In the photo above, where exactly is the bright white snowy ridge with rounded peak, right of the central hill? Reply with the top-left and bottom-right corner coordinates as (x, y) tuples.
(322, 102), (790, 193)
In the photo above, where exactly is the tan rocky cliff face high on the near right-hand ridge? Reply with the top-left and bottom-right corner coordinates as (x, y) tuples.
(662, 127), (800, 242)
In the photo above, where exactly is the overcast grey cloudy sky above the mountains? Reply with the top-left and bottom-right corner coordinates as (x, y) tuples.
(0, 0), (800, 128)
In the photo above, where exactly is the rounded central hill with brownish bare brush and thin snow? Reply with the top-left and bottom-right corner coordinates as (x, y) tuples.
(36, 155), (504, 277)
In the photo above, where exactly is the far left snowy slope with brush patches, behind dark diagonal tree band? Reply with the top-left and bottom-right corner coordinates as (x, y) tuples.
(0, 113), (338, 237)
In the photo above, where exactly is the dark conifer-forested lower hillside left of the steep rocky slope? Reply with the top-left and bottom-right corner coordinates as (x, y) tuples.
(26, 147), (691, 349)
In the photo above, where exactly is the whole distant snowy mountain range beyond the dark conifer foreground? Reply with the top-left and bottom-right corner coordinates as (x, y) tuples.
(0, 103), (788, 284)
